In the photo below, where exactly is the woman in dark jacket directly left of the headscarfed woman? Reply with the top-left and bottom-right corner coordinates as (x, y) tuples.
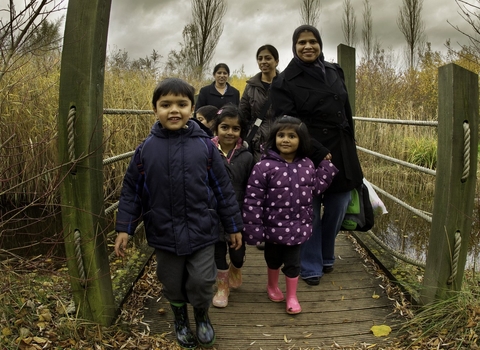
(240, 44), (278, 162)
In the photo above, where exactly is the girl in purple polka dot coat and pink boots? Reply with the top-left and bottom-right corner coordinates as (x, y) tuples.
(243, 116), (338, 314)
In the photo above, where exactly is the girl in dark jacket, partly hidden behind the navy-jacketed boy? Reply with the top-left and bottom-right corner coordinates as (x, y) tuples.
(210, 104), (253, 307)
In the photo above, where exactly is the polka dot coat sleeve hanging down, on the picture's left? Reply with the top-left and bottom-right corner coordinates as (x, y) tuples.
(243, 162), (268, 245)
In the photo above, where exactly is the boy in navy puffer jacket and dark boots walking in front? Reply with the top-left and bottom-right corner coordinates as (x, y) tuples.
(115, 78), (243, 349)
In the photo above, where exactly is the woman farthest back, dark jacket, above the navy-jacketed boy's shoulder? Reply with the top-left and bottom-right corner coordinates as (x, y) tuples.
(195, 63), (240, 112)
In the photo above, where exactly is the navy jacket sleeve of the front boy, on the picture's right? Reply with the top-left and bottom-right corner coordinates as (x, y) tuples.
(208, 141), (243, 233)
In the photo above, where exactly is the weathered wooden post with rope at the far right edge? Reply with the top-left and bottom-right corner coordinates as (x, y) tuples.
(421, 63), (478, 305)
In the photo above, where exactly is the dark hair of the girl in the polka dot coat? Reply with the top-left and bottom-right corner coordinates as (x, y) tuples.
(264, 115), (311, 158)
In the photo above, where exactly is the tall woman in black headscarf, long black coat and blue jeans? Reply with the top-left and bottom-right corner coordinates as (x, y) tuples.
(271, 25), (363, 285)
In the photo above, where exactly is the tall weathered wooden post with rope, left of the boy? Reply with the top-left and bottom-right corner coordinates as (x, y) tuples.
(58, 0), (115, 325)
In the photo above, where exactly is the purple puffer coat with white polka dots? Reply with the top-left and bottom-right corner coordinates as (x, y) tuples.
(243, 152), (337, 245)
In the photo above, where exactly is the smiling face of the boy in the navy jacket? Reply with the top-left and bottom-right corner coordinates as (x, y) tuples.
(153, 94), (193, 131)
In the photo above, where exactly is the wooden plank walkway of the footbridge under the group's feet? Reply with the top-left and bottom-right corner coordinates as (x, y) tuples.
(143, 232), (398, 350)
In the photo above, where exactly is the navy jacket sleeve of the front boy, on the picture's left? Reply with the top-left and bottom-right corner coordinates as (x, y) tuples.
(115, 146), (145, 236)
